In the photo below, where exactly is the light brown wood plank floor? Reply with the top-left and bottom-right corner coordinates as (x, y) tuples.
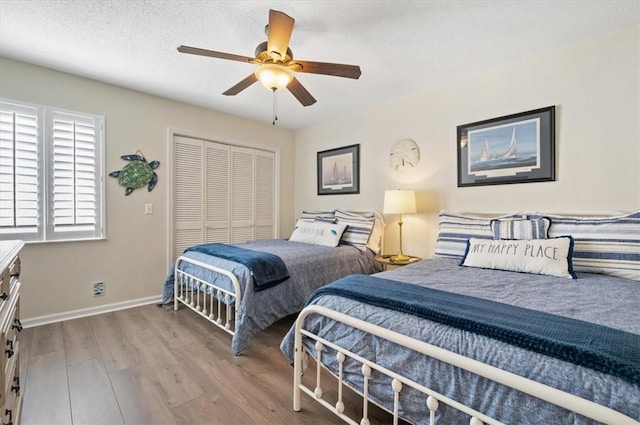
(20, 305), (398, 425)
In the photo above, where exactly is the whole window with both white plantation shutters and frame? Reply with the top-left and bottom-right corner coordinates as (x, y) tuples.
(0, 100), (104, 241)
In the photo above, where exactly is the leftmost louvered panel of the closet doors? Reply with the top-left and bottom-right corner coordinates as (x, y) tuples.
(173, 136), (204, 259)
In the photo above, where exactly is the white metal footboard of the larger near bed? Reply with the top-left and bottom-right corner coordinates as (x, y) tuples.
(293, 305), (640, 425)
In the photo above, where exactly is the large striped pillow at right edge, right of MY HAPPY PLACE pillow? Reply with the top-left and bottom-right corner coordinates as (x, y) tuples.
(530, 211), (640, 281)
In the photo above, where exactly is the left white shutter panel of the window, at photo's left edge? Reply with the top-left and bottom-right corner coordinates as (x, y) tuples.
(0, 102), (44, 240)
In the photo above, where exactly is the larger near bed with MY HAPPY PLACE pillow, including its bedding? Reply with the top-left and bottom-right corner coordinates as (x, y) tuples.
(281, 212), (640, 425)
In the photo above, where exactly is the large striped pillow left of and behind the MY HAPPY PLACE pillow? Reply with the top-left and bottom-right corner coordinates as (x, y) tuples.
(434, 211), (523, 258)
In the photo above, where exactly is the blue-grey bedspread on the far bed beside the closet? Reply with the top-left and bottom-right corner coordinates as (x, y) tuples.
(162, 239), (380, 355)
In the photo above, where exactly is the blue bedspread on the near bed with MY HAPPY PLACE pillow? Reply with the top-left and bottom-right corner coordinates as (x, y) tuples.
(284, 258), (640, 425)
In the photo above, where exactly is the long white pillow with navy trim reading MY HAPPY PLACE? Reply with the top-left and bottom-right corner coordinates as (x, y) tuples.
(460, 236), (577, 279)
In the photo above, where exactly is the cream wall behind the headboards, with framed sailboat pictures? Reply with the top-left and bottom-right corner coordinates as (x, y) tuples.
(295, 26), (640, 257)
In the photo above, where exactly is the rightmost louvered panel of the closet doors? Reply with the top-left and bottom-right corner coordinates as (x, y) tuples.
(255, 151), (275, 239)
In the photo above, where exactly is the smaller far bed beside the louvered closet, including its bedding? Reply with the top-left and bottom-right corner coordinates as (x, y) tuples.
(162, 210), (384, 355)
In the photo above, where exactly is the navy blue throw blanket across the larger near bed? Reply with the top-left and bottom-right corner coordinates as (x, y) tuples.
(307, 275), (640, 385)
